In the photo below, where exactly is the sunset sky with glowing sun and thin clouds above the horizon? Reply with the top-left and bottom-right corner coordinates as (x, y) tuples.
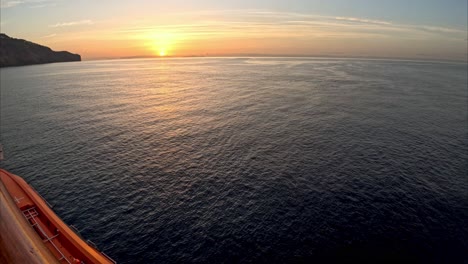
(0, 0), (468, 61)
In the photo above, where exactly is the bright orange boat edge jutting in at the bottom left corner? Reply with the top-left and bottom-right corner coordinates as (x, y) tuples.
(0, 169), (116, 264)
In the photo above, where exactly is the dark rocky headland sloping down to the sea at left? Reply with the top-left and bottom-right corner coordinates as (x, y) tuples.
(0, 33), (81, 67)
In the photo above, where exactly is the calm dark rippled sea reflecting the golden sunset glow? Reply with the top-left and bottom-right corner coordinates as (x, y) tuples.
(0, 58), (468, 263)
